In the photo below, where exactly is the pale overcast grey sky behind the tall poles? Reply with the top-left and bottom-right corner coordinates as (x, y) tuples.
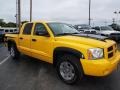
(0, 0), (120, 25)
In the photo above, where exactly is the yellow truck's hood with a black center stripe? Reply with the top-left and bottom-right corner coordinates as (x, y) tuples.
(55, 34), (112, 47)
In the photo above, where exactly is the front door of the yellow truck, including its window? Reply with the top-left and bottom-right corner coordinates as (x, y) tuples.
(31, 23), (53, 63)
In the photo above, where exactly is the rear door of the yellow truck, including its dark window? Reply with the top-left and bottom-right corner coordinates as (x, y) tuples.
(19, 23), (33, 55)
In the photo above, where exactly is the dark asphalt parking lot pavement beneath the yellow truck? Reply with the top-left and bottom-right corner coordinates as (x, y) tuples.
(0, 44), (120, 90)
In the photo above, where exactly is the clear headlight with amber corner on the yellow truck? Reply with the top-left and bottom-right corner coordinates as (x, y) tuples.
(88, 48), (104, 60)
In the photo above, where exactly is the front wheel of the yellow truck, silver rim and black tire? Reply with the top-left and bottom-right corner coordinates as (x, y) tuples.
(56, 54), (83, 84)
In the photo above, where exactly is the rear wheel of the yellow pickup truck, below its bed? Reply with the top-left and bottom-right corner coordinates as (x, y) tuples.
(10, 44), (20, 59)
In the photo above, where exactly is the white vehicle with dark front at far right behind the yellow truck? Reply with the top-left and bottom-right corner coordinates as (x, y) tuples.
(94, 26), (120, 41)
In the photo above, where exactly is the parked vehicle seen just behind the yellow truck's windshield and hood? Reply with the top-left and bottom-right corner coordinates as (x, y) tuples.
(74, 24), (96, 34)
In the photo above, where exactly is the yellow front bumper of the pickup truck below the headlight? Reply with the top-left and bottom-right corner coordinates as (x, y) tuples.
(80, 52), (120, 76)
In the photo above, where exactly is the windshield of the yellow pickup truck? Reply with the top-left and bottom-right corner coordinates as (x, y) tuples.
(48, 23), (79, 36)
